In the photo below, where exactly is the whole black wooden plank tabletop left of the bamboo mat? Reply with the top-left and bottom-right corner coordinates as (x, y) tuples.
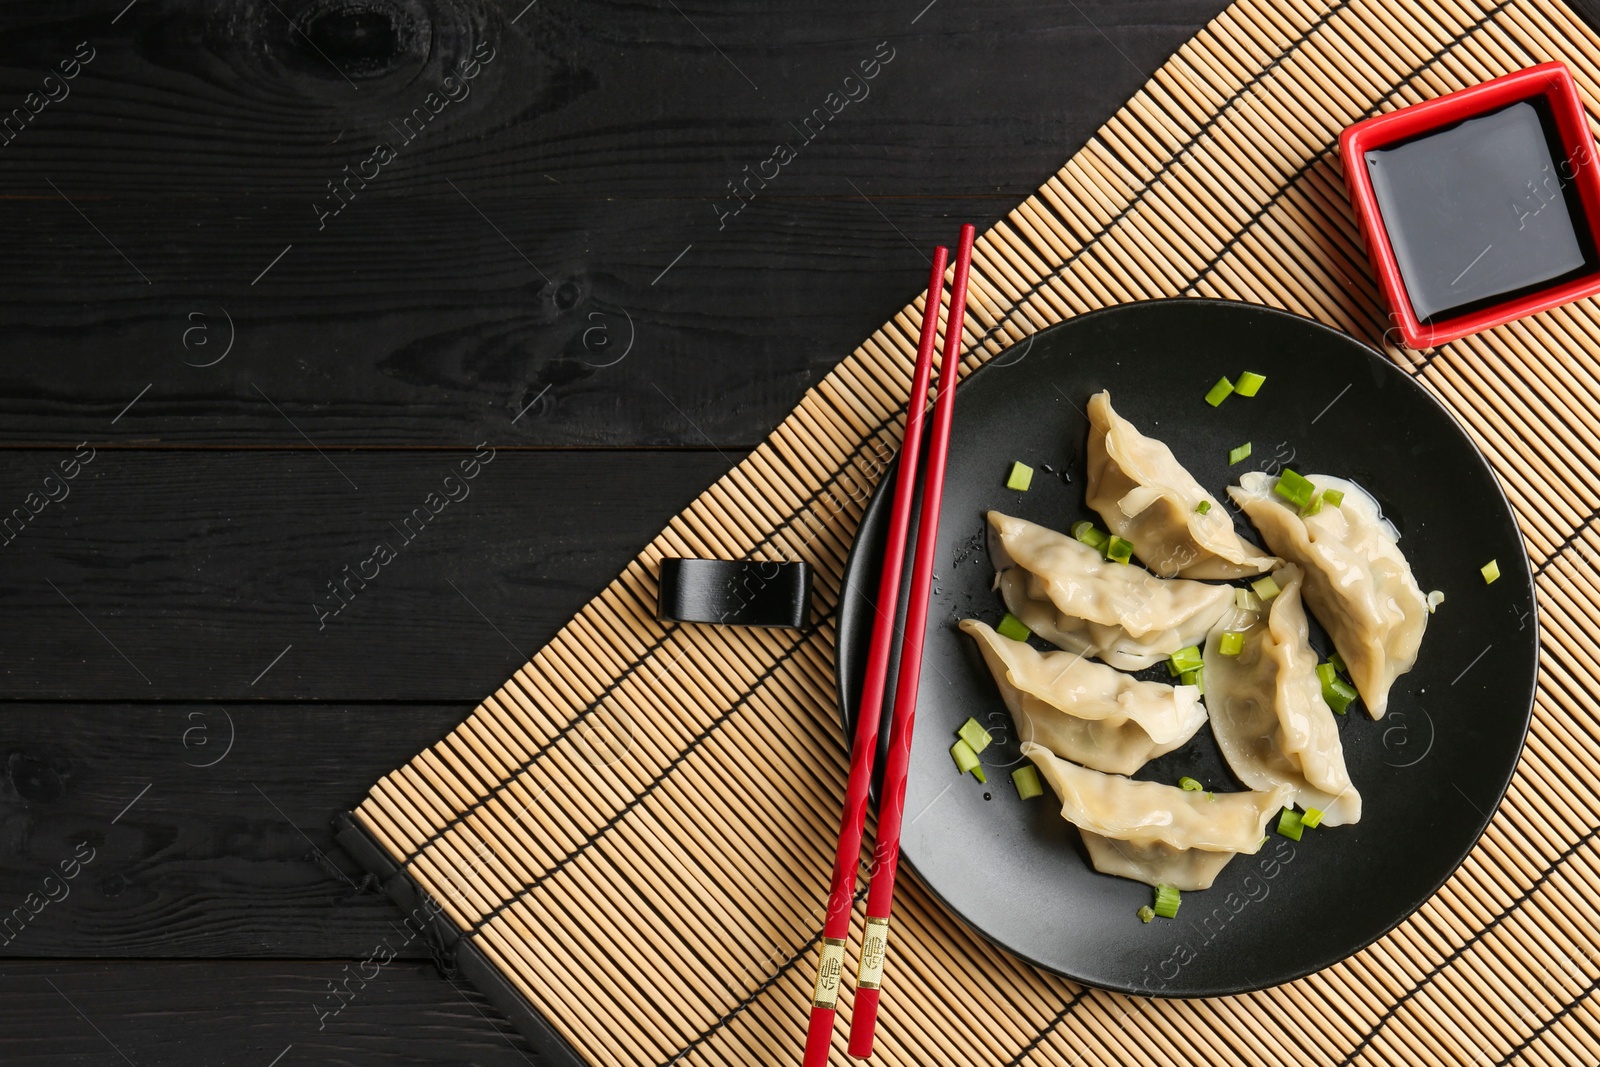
(0, 0), (1587, 1067)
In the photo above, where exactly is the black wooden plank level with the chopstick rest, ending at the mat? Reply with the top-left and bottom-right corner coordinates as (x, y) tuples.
(0, 448), (739, 704)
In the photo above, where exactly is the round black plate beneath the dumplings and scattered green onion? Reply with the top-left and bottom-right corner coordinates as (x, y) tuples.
(838, 301), (1538, 997)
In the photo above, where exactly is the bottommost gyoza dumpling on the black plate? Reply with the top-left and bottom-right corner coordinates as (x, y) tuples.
(1022, 742), (1290, 889)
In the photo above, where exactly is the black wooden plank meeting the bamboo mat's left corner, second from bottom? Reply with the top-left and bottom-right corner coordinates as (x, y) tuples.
(0, 704), (496, 960)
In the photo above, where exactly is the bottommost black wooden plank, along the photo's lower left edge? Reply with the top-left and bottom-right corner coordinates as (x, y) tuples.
(0, 957), (539, 1067)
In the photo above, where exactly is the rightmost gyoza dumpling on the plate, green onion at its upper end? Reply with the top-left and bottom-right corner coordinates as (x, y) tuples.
(1229, 470), (1427, 718)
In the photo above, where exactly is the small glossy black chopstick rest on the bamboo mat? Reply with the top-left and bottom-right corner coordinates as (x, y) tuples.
(656, 558), (811, 629)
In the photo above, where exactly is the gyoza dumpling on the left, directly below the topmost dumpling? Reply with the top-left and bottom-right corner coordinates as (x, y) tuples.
(989, 512), (1234, 670)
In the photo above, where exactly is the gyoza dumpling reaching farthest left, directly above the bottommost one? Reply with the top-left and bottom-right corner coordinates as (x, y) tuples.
(962, 619), (1205, 774)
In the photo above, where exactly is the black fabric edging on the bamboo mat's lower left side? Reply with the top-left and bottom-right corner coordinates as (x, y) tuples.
(333, 811), (587, 1067)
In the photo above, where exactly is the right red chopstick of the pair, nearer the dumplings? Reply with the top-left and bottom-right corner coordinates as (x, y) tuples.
(850, 226), (976, 1057)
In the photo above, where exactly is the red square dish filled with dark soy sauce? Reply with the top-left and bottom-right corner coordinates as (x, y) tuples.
(1339, 62), (1600, 349)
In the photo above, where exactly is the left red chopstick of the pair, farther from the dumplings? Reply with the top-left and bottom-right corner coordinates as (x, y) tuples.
(805, 245), (950, 1067)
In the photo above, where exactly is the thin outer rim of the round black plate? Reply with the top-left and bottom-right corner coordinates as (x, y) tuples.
(834, 296), (1544, 1000)
